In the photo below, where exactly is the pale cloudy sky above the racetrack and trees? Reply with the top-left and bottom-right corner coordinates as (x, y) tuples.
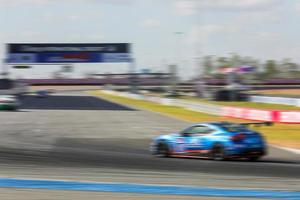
(0, 0), (300, 77)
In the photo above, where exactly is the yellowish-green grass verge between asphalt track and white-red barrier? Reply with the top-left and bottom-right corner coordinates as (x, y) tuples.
(90, 91), (300, 149)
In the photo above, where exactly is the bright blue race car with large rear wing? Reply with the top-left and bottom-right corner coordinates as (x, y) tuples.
(150, 122), (272, 161)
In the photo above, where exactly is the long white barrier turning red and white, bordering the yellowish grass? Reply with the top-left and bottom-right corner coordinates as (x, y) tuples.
(104, 90), (300, 124)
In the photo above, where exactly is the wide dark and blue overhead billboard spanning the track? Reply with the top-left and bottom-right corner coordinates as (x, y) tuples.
(6, 43), (131, 64)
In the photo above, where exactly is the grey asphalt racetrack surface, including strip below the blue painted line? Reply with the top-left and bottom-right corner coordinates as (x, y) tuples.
(0, 92), (300, 199)
